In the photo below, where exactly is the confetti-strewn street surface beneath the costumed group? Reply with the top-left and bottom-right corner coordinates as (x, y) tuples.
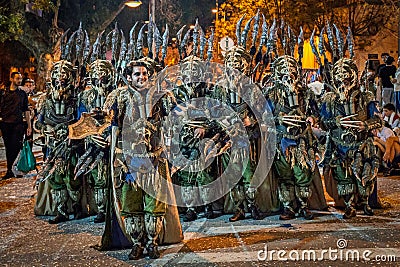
(0, 140), (400, 267)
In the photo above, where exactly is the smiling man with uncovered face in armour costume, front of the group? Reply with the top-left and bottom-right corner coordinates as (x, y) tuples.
(106, 57), (179, 260)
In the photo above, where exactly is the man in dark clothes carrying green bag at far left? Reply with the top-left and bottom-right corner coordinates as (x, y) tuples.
(0, 72), (32, 180)
